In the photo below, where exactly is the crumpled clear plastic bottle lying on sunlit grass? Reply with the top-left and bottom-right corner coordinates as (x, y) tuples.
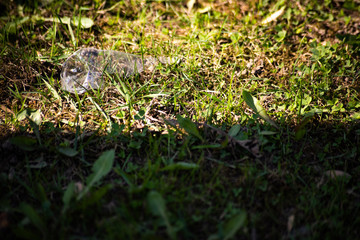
(60, 48), (177, 94)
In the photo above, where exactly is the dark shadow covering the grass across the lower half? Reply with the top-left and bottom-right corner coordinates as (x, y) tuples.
(0, 111), (360, 239)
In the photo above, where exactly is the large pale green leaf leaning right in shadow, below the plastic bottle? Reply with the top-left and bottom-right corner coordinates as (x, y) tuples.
(77, 149), (115, 200)
